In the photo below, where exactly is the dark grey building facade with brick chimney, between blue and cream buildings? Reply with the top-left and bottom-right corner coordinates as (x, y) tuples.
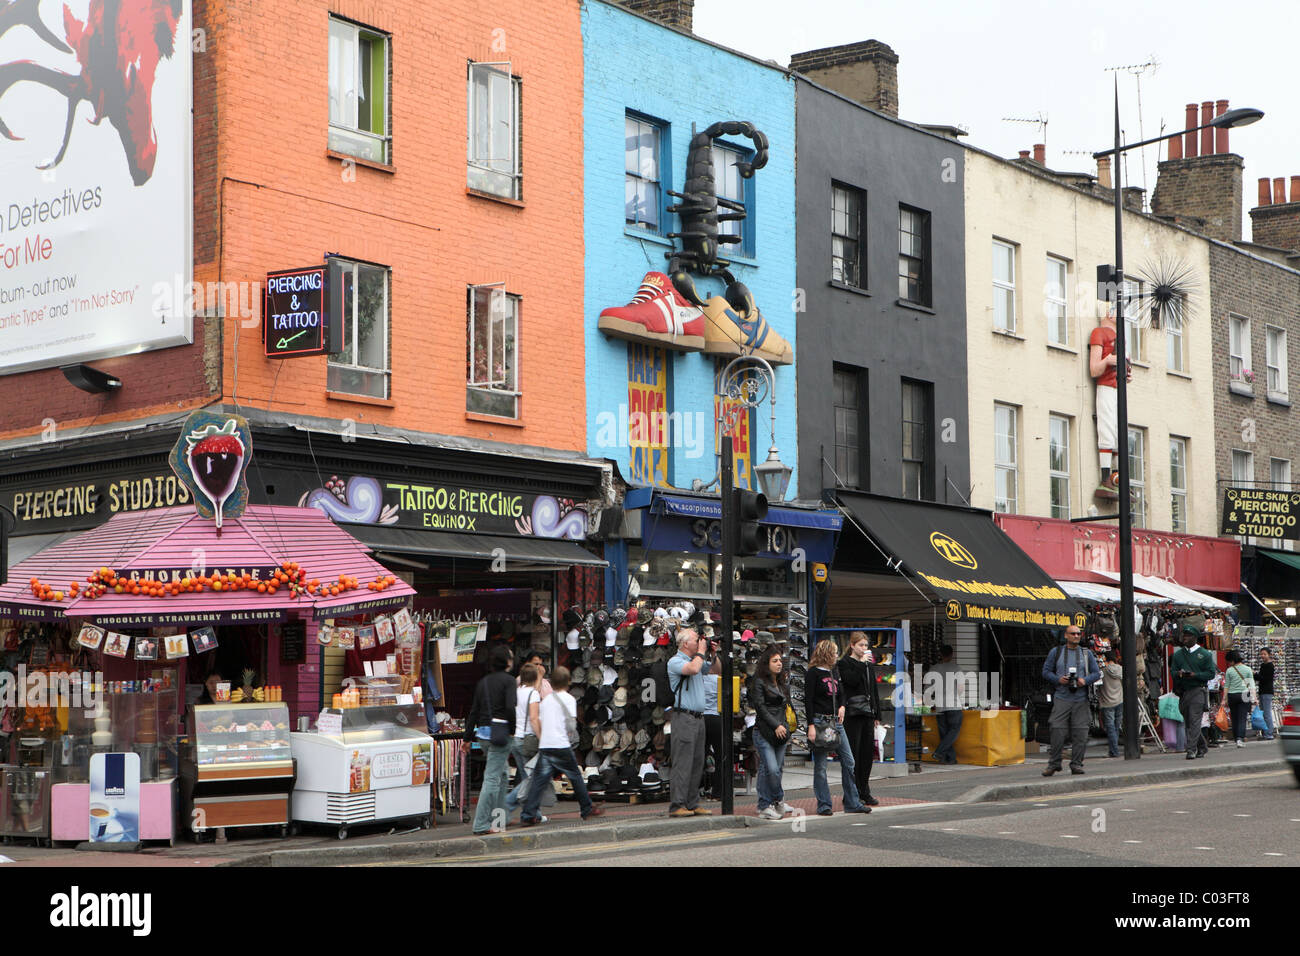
(790, 40), (970, 503)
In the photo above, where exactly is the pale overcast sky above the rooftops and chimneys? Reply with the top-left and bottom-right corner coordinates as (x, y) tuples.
(694, 0), (1300, 239)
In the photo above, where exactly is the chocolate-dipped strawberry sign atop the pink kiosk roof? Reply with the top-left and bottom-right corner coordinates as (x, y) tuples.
(168, 410), (252, 528)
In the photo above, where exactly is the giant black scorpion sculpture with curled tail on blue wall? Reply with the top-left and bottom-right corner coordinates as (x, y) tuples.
(664, 121), (767, 306)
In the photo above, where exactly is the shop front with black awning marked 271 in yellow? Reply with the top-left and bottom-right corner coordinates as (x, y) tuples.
(819, 492), (1084, 770)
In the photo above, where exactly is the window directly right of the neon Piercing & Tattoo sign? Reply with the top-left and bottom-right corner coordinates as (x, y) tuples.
(326, 259), (390, 398)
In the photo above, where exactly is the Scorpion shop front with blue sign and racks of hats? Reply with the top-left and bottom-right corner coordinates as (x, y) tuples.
(590, 488), (842, 790)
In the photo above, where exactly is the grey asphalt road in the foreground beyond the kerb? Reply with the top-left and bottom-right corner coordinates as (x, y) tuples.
(395, 770), (1300, 871)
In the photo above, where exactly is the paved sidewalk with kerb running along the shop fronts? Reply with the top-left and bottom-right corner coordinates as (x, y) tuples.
(0, 740), (1283, 868)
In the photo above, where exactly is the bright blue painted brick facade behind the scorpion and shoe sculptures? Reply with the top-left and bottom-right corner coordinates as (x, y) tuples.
(582, 0), (798, 494)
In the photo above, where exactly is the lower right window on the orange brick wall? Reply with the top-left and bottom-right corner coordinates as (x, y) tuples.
(465, 285), (519, 419)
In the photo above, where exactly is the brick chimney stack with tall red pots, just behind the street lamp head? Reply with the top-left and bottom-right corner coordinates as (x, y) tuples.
(1151, 100), (1253, 242)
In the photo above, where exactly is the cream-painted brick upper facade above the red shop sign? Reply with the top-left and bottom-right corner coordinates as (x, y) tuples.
(965, 148), (1217, 536)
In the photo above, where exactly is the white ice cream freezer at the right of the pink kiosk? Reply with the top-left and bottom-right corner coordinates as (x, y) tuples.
(291, 704), (433, 839)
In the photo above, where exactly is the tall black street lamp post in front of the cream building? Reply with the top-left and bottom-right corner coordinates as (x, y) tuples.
(1092, 93), (1264, 760)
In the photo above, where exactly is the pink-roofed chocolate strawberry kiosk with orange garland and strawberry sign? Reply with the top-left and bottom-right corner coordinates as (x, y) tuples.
(0, 412), (421, 843)
